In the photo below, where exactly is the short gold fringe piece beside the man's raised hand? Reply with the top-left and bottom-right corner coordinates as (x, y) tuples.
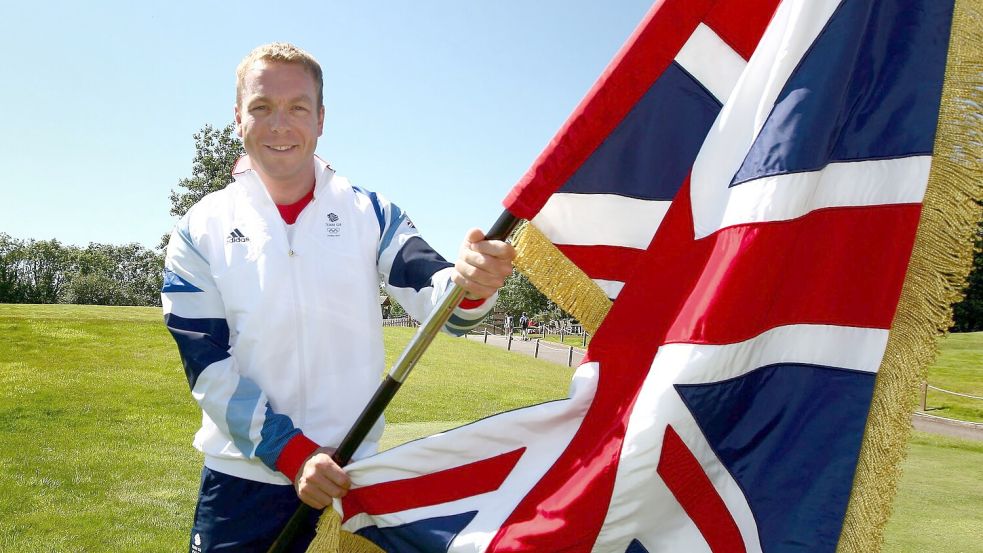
(512, 221), (612, 334)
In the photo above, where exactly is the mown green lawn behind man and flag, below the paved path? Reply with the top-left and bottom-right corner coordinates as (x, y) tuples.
(0, 305), (983, 553)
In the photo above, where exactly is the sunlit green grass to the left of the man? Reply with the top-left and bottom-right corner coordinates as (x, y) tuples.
(0, 305), (201, 551)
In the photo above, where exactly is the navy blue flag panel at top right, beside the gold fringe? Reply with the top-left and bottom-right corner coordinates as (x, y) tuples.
(731, 0), (952, 186)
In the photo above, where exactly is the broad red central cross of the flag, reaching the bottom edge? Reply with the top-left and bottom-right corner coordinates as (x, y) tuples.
(488, 185), (920, 553)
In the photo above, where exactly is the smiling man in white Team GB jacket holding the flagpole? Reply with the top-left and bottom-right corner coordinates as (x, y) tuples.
(162, 43), (515, 551)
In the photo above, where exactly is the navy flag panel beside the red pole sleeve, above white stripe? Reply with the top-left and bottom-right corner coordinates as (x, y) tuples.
(559, 62), (720, 200)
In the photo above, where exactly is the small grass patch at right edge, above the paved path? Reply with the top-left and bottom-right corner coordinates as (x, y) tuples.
(927, 332), (983, 420)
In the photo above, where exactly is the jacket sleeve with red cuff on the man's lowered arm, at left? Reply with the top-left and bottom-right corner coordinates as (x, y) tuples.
(161, 216), (317, 481)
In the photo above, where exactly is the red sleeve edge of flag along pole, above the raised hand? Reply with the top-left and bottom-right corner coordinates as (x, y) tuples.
(502, 0), (714, 219)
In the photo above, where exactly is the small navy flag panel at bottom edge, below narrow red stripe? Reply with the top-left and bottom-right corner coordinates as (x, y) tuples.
(355, 511), (478, 553)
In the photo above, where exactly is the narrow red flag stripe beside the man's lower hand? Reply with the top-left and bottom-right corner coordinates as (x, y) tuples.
(341, 447), (526, 521)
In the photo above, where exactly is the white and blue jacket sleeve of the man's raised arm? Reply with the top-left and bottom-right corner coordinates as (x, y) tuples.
(356, 188), (498, 336)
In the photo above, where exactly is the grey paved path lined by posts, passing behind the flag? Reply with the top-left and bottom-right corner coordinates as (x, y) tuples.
(468, 334), (983, 441)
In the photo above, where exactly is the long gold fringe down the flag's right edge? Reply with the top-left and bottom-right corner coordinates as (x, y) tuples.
(837, 0), (983, 553)
